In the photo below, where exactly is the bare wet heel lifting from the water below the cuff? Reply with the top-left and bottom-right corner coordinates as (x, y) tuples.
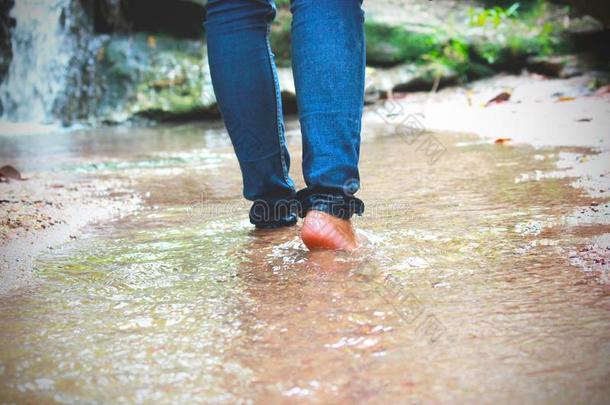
(301, 210), (358, 250)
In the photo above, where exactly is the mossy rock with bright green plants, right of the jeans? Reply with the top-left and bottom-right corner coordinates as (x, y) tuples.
(365, 0), (581, 76)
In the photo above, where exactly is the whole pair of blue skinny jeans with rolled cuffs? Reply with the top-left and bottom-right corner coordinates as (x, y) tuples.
(205, 0), (365, 227)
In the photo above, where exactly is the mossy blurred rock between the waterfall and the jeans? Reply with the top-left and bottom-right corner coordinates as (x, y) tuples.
(98, 34), (215, 122)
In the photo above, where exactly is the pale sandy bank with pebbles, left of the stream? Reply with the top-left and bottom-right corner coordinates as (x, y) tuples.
(0, 172), (140, 296)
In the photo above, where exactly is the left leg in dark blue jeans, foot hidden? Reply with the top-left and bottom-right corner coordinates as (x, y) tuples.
(205, 0), (297, 227)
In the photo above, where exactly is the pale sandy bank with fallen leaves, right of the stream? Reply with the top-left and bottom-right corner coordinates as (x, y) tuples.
(363, 74), (610, 278)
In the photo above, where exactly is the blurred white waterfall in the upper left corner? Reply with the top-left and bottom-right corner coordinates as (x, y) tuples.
(0, 0), (75, 124)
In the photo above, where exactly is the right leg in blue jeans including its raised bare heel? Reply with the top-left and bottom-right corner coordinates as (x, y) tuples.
(292, 0), (365, 248)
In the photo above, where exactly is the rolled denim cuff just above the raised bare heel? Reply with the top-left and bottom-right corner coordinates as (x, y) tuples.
(297, 189), (364, 219)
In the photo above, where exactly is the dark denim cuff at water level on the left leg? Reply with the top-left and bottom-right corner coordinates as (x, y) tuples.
(250, 198), (298, 229)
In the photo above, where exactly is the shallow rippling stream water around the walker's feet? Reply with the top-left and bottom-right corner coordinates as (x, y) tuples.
(0, 124), (610, 403)
